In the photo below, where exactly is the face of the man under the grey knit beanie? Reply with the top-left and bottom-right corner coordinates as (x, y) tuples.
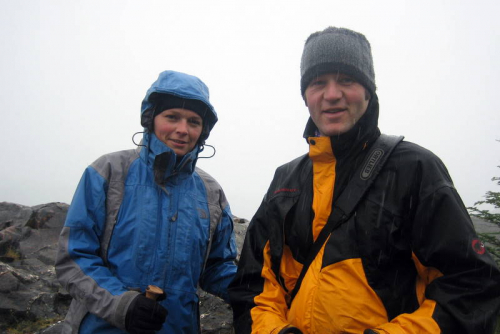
(305, 73), (369, 136)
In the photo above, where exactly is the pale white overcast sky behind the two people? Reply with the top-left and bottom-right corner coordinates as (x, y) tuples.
(0, 0), (500, 219)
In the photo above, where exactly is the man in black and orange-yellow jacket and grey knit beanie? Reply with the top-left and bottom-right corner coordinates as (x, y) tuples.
(229, 27), (500, 334)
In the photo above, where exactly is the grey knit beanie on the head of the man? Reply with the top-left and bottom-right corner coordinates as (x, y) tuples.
(300, 27), (376, 97)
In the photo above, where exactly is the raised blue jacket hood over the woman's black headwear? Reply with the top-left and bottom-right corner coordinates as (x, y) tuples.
(141, 71), (218, 134)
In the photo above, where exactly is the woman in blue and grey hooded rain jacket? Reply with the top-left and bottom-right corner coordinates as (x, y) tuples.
(56, 71), (236, 334)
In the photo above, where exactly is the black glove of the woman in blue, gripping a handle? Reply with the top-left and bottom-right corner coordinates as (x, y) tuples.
(125, 295), (168, 334)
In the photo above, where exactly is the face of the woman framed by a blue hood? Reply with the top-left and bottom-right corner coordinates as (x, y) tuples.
(154, 108), (203, 156)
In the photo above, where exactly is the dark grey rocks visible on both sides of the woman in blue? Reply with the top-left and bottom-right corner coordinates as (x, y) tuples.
(0, 202), (248, 334)
